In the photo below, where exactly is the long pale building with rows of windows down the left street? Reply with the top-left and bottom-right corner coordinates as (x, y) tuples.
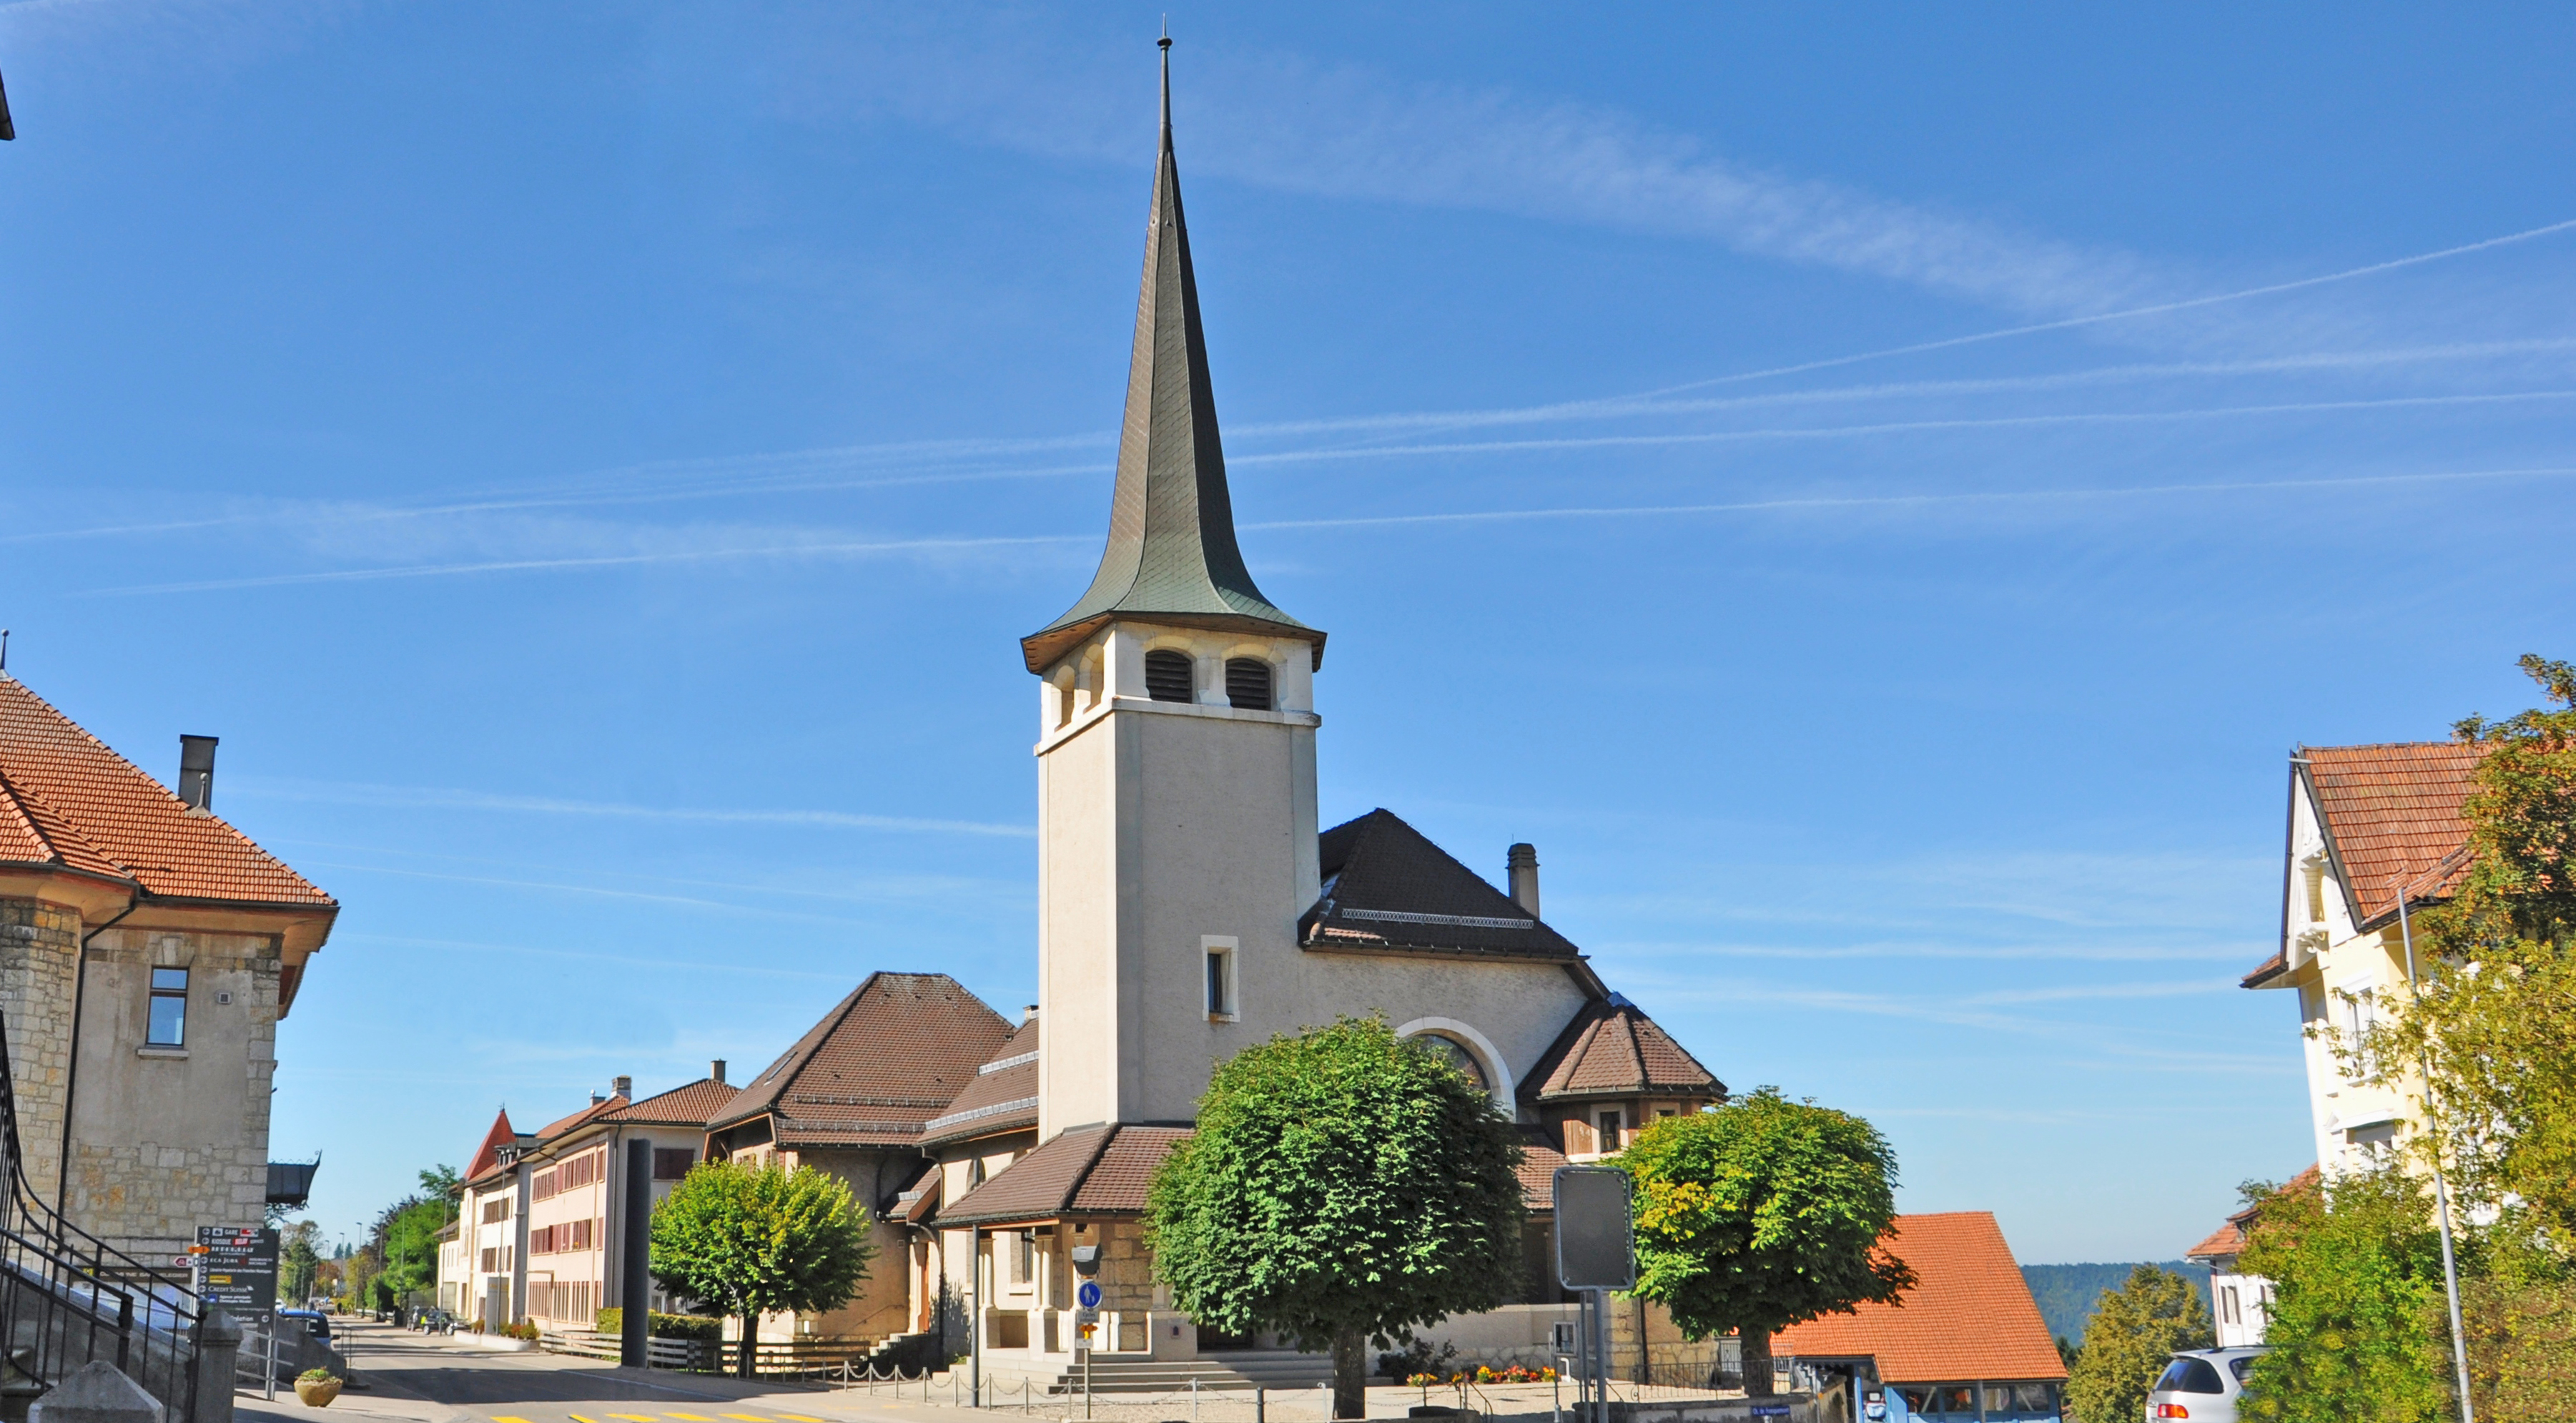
(438, 1060), (736, 1333)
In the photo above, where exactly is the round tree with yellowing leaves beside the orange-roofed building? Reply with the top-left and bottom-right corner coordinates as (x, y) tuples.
(1618, 1088), (1914, 1397)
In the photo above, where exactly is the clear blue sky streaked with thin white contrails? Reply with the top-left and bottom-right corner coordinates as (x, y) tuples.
(0, 0), (2576, 1261)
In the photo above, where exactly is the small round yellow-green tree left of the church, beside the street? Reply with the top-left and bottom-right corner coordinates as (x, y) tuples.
(652, 1160), (876, 1379)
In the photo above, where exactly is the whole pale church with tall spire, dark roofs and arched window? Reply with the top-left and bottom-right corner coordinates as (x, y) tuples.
(876, 49), (1726, 1379)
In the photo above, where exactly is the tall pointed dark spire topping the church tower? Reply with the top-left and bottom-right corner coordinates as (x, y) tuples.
(1020, 36), (1324, 673)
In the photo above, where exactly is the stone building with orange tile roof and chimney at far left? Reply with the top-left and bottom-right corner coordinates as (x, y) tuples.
(0, 673), (340, 1261)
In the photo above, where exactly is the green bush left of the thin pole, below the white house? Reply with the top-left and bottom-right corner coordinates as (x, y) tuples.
(2246, 1165), (2457, 1423)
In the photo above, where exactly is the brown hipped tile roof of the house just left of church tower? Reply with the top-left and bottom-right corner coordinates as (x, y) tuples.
(709, 972), (1012, 1147)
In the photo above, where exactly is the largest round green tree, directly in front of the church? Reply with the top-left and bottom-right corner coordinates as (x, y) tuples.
(1146, 1018), (1528, 1418)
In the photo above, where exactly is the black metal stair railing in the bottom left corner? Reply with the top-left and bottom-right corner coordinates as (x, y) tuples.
(0, 1023), (208, 1423)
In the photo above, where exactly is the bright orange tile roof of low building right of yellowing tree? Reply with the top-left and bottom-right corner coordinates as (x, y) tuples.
(1772, 1211), (2066, 1384)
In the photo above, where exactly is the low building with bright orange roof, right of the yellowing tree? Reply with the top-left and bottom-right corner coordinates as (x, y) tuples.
(1772, 1211), (2066, 1423)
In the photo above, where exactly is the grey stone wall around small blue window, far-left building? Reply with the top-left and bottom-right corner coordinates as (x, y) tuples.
(64, 928), (278, 1261)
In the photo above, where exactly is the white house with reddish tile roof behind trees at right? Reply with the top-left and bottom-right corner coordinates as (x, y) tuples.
(2244, 742), (2483, 1176)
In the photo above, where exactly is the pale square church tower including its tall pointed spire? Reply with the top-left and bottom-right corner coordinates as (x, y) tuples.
(1020, 39), (1324, 1142)
